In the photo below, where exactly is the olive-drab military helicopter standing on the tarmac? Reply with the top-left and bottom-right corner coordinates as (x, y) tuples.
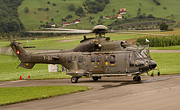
(10, 25), (160, 83)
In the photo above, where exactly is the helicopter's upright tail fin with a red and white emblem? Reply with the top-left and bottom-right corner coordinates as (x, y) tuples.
(10, 40), (35, 69)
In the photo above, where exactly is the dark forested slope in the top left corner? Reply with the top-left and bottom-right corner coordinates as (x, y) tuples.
(0, 0), (24, 37)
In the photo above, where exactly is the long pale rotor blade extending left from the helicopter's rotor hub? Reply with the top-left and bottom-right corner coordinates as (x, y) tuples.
(25, 30), (92, 34)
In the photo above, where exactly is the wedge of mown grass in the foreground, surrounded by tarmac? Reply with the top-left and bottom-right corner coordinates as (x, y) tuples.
(0, 85), (91, 106)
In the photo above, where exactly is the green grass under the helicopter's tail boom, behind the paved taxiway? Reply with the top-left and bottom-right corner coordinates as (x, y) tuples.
(0, 55), (70, 81)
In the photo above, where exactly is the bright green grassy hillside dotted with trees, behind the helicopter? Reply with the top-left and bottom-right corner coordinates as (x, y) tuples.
(18, 0), (180, 30)
